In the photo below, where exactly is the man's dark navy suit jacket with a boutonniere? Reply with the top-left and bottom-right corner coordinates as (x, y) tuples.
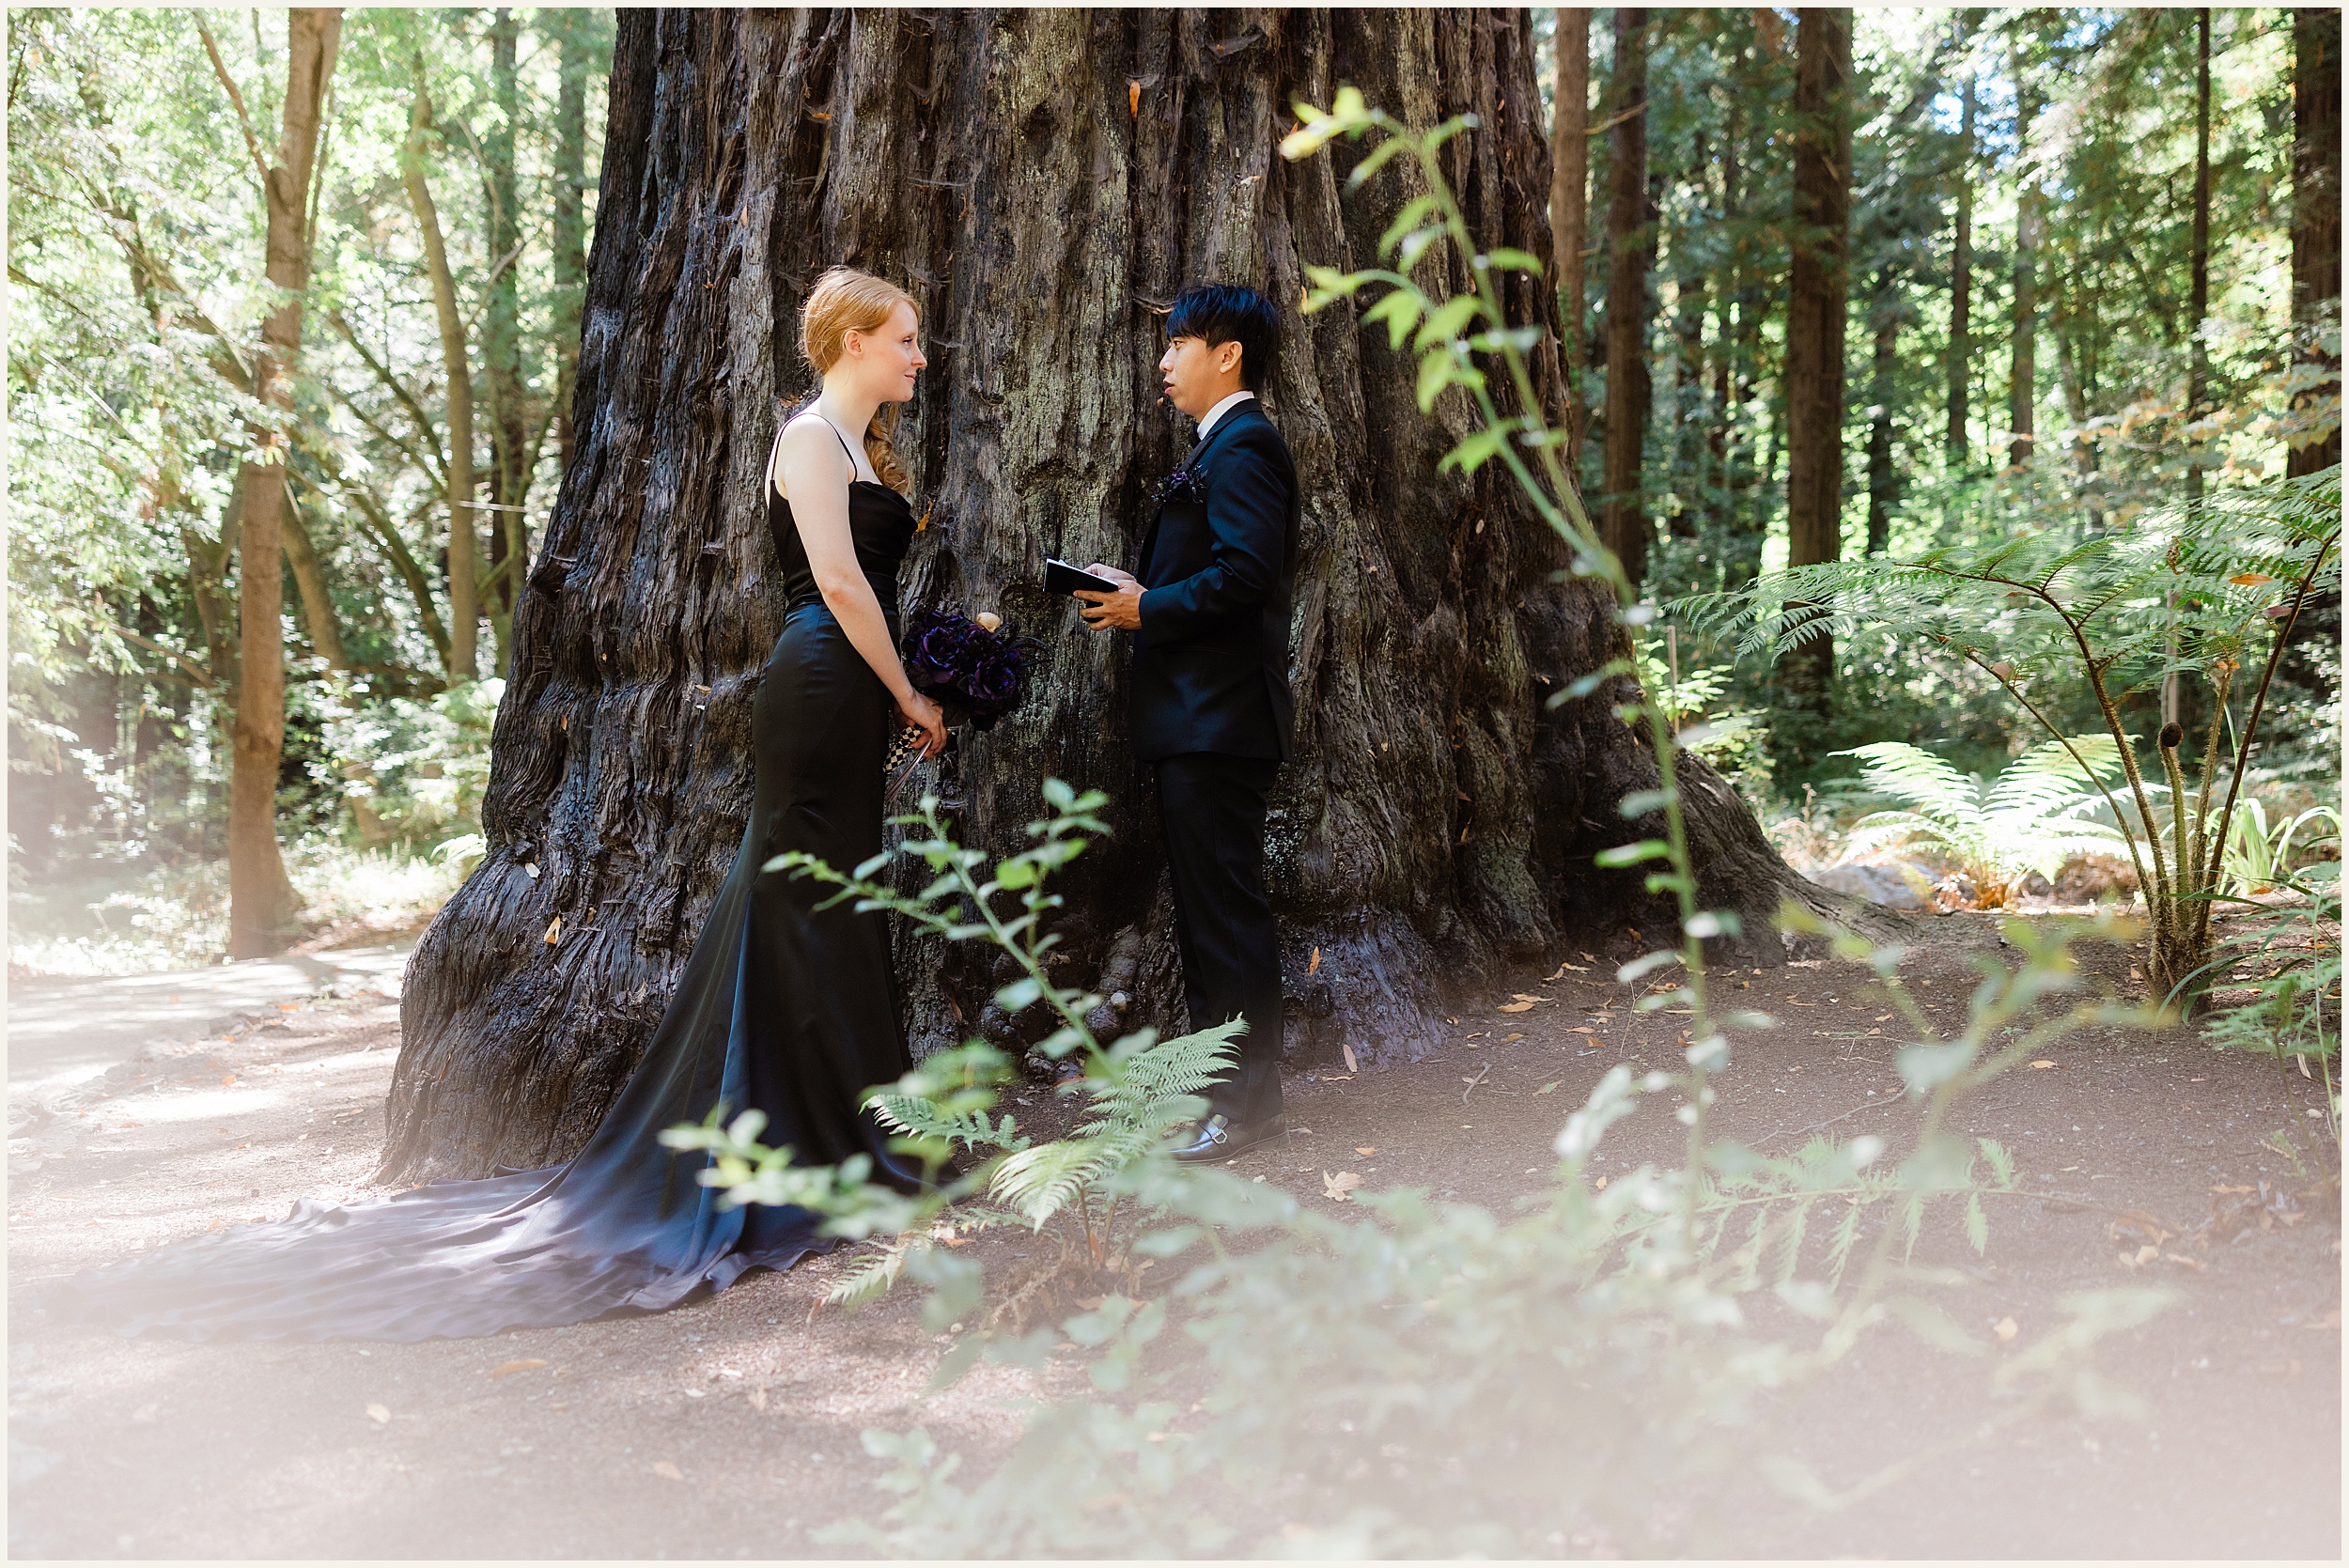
(1132, 399), (1299, 763)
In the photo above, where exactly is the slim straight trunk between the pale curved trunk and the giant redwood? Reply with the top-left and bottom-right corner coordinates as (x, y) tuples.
(482, 9), (531, 672)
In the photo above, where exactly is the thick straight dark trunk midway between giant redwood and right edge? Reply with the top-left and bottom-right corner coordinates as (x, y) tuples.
(1779, 7), (1851, 714)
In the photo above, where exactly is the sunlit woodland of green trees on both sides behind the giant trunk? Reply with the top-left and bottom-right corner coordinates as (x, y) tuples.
(8, 7), (2340, 974)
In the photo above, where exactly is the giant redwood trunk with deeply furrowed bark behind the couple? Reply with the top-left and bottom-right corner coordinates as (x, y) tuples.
(385, 9), (1790, 1178)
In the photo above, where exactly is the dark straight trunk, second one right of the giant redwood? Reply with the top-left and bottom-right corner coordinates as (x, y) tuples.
(1597, 5), (1654, 582)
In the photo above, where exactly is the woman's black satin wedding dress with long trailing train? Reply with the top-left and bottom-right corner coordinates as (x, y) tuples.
(61, 459), (919, 1341)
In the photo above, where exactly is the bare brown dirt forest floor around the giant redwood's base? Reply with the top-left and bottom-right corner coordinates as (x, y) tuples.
(8, 915), (2342, 1559)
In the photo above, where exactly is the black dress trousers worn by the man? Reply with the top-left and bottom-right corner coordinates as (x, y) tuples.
(1159, 752), (1281, 1122)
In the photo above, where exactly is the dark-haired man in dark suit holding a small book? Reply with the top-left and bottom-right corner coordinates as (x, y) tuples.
(1079, 287), (1299, 1159)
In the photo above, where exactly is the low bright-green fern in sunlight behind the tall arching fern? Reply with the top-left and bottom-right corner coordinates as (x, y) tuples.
(1837, 735), (2122, 908)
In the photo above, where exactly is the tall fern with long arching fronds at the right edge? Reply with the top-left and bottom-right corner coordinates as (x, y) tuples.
(1675, 465), (2342, 1007)
